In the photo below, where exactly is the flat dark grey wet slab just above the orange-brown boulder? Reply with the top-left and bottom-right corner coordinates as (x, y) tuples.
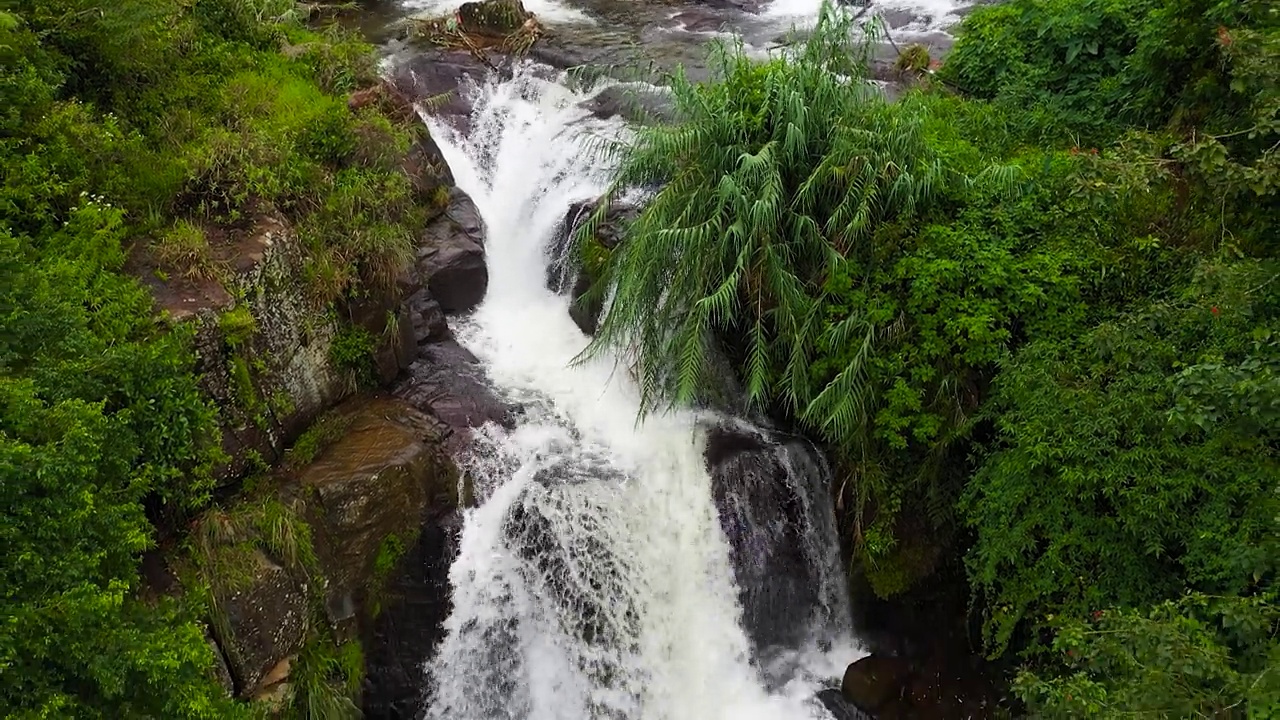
(396, 341), (515, 451)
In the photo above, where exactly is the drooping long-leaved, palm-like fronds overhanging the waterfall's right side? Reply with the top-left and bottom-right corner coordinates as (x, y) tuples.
(577, 1), (998, 442)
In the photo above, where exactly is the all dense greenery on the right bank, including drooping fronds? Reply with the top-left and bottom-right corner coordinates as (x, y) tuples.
(579, 0), (1280, 717)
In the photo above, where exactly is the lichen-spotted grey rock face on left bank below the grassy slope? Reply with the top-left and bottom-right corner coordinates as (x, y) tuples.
(137, 214), (412, 486)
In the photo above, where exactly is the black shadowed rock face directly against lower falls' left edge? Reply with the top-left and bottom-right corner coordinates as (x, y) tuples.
(362, 510), (462, 720)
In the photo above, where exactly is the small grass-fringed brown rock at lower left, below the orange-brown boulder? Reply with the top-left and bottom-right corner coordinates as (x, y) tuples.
(214, 551), (307, 697)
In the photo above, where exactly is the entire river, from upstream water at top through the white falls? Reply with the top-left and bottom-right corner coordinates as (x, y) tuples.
(366, 0), (972, 720)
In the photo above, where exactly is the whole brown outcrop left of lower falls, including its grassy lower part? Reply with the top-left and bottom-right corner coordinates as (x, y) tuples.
(201, 396), (471, 706)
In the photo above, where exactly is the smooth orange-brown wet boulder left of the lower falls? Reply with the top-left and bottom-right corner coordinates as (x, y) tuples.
(298, 397), (457, 629)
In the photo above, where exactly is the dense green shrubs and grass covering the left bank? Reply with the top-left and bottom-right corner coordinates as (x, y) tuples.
(0, 0), (422, 719)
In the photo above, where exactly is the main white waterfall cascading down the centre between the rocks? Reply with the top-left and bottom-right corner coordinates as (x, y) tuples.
(428, 65), (856, 720)
